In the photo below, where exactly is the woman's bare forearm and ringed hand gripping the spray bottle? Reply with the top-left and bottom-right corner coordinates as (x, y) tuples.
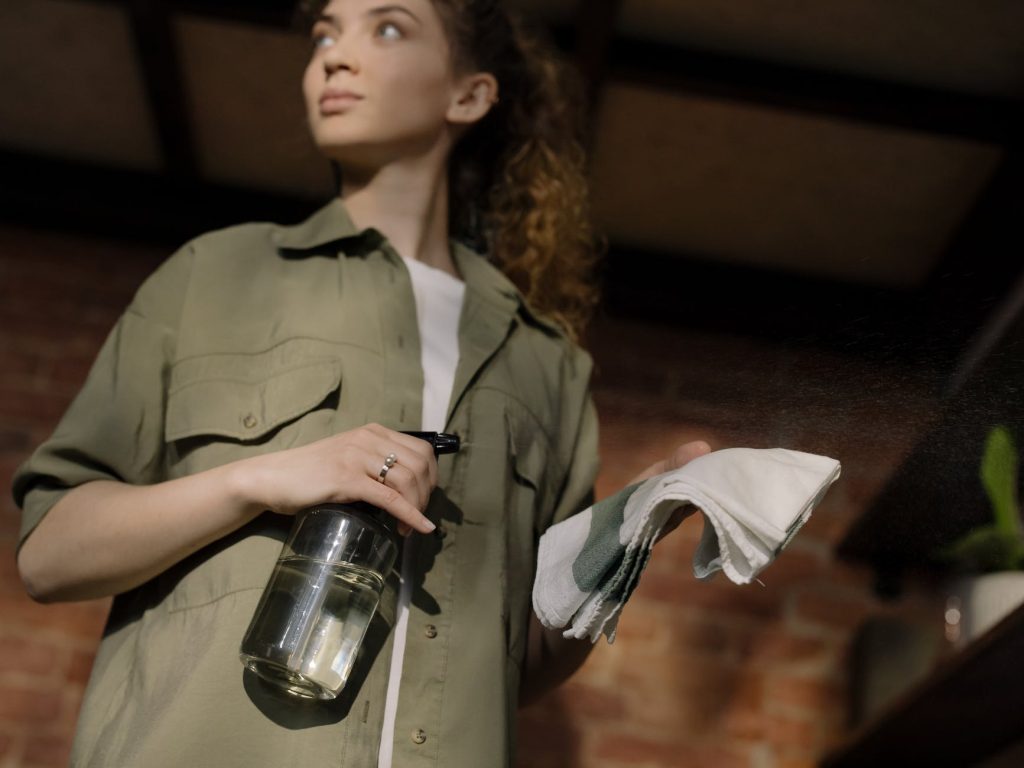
(17, 425), (437, 602)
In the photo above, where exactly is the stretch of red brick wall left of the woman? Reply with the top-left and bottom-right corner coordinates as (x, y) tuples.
(0, 227), (161, 768)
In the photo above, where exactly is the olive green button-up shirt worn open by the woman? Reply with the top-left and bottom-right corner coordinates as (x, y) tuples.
(14, 199), (597, 768)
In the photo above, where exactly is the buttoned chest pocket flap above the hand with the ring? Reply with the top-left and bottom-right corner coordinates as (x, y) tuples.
(165, 352), (341, 441)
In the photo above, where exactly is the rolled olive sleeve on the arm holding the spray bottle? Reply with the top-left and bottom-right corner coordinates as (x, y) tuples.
(12, 245), (193, 549)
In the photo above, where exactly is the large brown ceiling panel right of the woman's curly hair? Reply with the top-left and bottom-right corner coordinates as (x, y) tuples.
(593, 84), (1001, 286)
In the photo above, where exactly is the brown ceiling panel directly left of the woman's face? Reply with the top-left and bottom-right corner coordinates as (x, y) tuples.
(175, 16), (332, 198)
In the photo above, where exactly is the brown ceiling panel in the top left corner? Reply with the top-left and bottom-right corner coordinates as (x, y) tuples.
(0, 0), (161, 170)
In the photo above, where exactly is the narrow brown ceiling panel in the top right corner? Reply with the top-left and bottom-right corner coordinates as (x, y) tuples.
(621, 0), (1024, 97)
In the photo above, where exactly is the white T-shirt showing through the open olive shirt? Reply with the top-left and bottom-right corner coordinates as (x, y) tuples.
(377, 259), (466, 768)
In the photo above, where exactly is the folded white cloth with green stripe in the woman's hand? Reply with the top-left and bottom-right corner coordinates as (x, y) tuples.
(534, 447), (840, 643)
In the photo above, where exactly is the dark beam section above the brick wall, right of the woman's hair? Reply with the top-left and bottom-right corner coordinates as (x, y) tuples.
(602, 246), (958, 370)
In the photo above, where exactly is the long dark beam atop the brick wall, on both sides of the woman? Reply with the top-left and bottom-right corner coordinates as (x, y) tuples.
(0, 151), (958, 368)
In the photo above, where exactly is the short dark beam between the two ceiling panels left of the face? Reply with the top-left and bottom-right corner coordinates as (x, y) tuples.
(127, 0), (199, 181)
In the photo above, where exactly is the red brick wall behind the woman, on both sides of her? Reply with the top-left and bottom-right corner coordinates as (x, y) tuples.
(0, 227), (933, 768)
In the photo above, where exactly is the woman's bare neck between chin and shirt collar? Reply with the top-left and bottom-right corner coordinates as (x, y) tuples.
(341, 145), (458, 275)
